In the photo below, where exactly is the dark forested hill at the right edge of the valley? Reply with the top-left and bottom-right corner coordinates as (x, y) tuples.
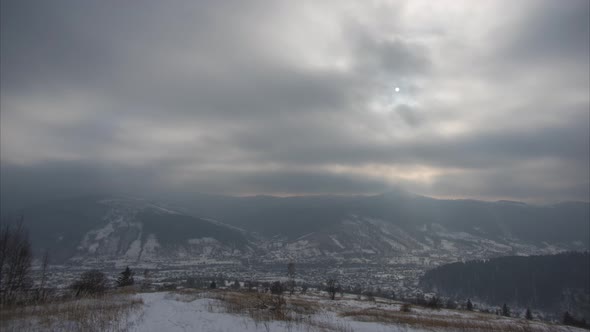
(420, 252), (590, 318)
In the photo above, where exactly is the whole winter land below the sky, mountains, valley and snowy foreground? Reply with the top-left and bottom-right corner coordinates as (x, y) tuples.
(2, 196), (590, 331)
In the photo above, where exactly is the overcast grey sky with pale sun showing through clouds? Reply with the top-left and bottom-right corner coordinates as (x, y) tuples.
(0, 0), (590, 202)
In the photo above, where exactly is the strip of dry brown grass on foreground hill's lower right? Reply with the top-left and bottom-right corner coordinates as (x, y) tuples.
(340, 308), (559, 332)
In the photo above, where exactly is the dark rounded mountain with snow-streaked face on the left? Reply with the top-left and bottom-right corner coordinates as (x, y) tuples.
(20, 197), (253, 264)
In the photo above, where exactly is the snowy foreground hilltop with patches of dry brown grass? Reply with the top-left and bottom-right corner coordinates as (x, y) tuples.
(0, 290), (585, 332)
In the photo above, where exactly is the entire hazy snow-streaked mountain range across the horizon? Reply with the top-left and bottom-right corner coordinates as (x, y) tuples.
(3, 192), (590, 266)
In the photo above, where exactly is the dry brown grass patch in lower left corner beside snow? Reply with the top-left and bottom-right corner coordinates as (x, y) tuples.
(0, 291), (143, 332)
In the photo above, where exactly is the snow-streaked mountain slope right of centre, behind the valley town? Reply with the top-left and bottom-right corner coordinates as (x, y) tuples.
(253, 215), (583, 265)
